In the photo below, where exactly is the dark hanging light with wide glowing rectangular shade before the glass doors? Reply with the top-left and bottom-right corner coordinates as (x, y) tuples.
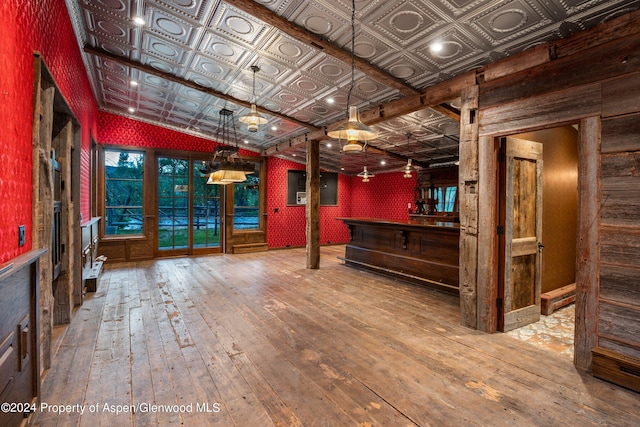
(200, 108), (254, 185)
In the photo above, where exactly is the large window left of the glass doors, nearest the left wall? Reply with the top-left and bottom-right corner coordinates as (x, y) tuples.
(104, 150), (144, 236)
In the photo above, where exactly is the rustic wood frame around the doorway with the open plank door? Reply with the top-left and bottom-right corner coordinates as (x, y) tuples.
(472, 114), (600, 369)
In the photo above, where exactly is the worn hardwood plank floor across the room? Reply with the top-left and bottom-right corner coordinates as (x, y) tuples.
(34, 246), (640, 427)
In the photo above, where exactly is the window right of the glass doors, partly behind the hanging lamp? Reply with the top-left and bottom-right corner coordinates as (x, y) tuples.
(233, 168), (260, 230)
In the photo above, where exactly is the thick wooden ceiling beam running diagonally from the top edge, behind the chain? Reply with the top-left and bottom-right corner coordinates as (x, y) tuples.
(229, 0), (418, 96)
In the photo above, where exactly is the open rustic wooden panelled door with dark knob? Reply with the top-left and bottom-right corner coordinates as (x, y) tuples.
(498, 137), (543, 332)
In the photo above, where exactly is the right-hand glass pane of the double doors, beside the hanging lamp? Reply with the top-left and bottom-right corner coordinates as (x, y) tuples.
(191, 160), (222, 248)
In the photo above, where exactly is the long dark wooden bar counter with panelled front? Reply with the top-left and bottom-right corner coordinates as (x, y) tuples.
(337, 218), (460, 294)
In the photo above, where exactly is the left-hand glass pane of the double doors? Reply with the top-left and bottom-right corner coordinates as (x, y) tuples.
(158, 157), (190, 253)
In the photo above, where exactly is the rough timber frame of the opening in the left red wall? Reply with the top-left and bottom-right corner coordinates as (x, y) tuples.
(32, 52), (82, 369)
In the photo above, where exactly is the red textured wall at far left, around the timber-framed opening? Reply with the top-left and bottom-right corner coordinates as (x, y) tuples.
(0, 0), (97, 263)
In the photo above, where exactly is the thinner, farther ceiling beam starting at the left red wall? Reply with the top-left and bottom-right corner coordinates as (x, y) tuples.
(84, 46), (321, 131)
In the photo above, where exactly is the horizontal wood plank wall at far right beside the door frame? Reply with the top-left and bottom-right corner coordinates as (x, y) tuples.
(598, 73), (640, 359)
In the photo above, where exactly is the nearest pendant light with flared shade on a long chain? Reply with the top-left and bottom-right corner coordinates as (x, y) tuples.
(327, 0), (378, 153)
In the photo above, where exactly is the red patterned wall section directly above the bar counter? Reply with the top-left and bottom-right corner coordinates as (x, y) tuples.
(351, 172), (417, 220)
